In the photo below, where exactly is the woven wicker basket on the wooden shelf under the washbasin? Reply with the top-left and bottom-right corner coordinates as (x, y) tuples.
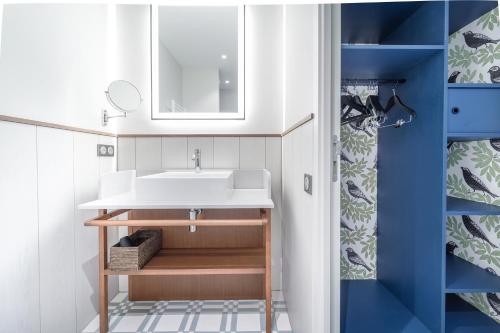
(109, 230), (162, 271)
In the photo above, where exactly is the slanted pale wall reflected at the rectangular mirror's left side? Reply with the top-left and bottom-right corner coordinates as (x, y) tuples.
(158, 41), (183, 112)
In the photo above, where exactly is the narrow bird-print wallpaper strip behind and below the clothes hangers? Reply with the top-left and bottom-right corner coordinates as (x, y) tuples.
(340, 86), (378, 280)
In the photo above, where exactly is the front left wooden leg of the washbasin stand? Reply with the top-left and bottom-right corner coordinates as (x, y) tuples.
(99, 218), (108, 333)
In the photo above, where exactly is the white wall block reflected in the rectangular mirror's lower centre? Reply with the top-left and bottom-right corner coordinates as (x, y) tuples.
(182, 67), (219, 113)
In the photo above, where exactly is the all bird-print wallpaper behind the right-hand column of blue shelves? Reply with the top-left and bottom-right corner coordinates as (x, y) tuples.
(446, 4), (500, 323)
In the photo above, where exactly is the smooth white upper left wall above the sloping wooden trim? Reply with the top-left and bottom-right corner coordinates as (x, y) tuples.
(0, 4), (112, 131)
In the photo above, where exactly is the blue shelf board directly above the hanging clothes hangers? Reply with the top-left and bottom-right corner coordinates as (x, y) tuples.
(341, 44), (444, 79)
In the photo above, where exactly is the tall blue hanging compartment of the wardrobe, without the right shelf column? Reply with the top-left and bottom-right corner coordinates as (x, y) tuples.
(341, 1), (447, 333)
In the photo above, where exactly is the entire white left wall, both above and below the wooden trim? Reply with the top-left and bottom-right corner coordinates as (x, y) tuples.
(0, 5), (118, 333)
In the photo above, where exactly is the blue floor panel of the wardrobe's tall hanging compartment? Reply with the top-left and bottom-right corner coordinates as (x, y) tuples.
(341, 280), (430, 333)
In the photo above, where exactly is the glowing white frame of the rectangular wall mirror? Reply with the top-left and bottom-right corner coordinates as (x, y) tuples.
(150, 5), (245, 120)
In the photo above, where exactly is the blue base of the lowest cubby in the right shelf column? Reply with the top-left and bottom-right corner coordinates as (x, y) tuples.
(446, 295), (499, 333)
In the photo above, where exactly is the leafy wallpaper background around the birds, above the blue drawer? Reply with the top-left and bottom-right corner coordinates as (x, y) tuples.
(448, 8), (500, 83)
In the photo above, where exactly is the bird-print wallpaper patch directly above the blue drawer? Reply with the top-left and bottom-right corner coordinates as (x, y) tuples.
(448, 7), (500, 83)
